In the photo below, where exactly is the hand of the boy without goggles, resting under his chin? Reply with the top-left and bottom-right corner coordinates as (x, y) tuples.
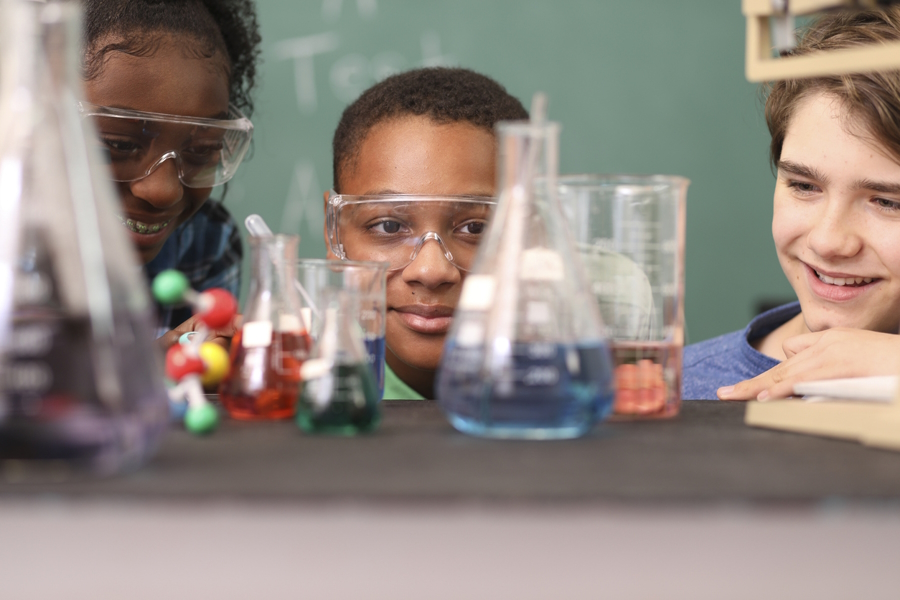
(716, 327), (900, 400)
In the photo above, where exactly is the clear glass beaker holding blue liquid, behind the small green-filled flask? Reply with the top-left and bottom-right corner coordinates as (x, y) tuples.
(297, 258), (390, 399)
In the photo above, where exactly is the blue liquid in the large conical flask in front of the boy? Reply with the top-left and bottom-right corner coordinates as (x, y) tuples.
(437, 343), (614, 439)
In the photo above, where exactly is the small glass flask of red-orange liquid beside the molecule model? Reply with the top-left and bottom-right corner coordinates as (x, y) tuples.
(219, 235), (310, 420)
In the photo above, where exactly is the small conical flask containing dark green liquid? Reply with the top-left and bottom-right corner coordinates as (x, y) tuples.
(297, 288), (381, 435)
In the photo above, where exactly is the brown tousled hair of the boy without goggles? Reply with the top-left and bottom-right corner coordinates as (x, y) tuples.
(766, 6), (900, 168)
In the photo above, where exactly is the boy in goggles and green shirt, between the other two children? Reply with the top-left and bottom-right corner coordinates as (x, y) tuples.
(325, 68), (528, 399)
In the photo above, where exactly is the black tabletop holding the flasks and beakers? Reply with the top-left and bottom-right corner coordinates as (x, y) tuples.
(0, 401), (900, 503)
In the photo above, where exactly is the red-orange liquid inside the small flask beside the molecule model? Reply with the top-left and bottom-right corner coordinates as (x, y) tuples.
(219, 330), (310, 420)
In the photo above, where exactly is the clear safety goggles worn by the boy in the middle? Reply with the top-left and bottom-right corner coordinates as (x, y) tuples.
(325, 191), (497, 271)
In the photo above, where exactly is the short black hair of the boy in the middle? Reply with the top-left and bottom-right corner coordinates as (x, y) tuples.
(332, 67), (528, 191)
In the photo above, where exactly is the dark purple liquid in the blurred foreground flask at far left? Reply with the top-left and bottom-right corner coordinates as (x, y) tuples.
(0, 310), (168, 474)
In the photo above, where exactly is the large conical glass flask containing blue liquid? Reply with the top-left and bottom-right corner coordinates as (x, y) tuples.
(437, 117), (613, 439)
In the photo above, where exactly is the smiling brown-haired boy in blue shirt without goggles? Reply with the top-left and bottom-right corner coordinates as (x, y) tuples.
(683, 8), (900, 400)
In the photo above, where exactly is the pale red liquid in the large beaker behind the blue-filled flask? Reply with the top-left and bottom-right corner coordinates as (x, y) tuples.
(611, 342), (681, 419)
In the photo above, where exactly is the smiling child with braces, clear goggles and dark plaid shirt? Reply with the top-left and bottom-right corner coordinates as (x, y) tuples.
(80, 0), (260, 346)
